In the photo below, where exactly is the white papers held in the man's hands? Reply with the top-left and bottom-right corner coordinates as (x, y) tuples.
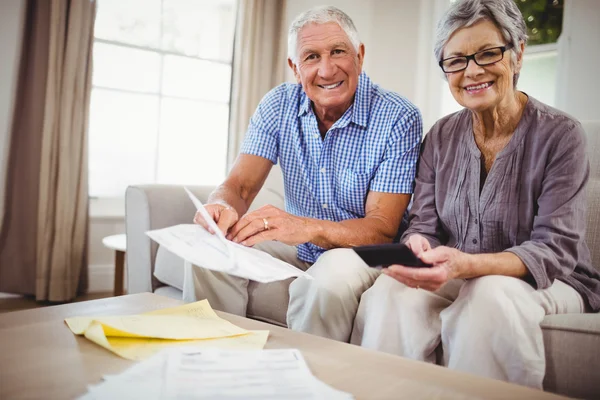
(146, 188), (312, 283)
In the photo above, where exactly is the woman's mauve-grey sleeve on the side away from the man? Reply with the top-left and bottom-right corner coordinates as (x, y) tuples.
(506, 123), (590, 289)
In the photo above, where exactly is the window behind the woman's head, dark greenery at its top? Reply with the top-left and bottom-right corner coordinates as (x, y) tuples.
(440, 0), (564, 117)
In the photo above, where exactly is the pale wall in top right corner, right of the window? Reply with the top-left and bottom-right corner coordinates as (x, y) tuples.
(556, 0), (600, 121)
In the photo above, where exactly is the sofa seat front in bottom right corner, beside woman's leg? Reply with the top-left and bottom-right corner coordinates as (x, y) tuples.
(542, 314), (600, 399)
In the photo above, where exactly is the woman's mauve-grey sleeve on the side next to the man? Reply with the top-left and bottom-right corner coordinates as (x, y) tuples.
(400, 125), (448, 247)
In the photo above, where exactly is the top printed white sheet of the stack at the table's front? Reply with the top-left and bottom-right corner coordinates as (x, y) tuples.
(163, 349), (352, 400)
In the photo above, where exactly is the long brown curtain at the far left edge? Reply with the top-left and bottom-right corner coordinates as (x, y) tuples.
(0, 0), (96, 302)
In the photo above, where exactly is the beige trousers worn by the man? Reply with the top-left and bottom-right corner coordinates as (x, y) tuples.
(183, 242), (380, 342)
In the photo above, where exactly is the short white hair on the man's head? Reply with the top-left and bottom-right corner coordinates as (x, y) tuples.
(288, 6), (360, 64)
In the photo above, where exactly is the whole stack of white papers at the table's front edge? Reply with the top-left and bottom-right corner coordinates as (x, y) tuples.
(82, 348), (353, 400)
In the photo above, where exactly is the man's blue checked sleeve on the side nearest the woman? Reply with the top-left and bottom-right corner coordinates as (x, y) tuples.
(370, 110), (423, 194)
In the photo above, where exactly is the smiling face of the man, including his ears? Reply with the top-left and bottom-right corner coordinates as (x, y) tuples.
(289, 22), (364, 116)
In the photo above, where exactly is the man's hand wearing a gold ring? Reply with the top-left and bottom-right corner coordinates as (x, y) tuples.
(227, 205), (312, 246)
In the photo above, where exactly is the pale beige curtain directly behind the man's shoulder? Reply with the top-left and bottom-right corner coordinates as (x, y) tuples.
(227, 0), (287, 167)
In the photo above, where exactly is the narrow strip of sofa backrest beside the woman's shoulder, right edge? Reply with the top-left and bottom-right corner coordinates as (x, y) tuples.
(582, 121), (600, 271)
